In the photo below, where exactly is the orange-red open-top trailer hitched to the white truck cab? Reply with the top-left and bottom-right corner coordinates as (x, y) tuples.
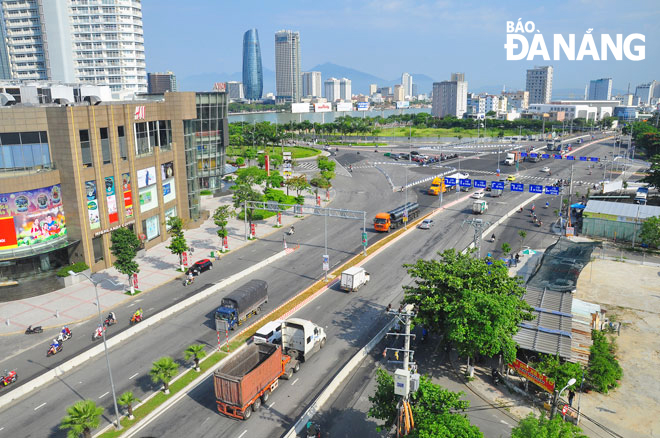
(213, 343), (300, 420)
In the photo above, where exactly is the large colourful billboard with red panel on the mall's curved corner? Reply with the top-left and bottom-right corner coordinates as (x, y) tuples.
(0, 184), (66, 249)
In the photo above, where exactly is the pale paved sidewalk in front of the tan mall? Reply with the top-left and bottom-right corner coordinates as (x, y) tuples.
(0, 186), (334, 335)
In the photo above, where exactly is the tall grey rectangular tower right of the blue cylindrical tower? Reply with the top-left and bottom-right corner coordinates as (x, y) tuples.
(275, 30), (301, 102)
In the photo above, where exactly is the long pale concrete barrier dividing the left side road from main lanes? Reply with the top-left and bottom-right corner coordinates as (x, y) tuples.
(0, 251), (287, 409)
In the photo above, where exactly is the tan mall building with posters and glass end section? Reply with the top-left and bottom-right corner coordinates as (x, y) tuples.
(0, 92), (228, 292)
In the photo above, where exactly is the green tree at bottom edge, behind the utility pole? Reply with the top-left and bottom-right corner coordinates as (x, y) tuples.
(368, 369), (483, 438)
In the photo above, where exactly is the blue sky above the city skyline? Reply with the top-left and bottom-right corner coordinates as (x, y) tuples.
(142, 0), (660, 92)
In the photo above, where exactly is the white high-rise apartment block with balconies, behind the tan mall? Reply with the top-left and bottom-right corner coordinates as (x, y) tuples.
(0, 0), (147, 96)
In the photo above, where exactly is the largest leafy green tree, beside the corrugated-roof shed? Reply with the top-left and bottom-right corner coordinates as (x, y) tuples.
(404, 249), (533, 363)
